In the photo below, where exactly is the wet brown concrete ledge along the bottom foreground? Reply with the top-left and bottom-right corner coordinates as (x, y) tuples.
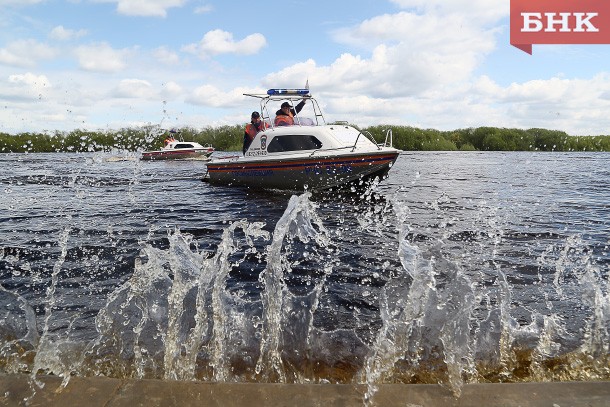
(0, 375), (610, 407)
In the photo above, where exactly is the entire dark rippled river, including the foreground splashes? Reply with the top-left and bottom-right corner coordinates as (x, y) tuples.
(0, 152), (610, 396)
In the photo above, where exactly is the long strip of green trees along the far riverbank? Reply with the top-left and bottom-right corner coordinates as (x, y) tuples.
(0, 125), (610, 153)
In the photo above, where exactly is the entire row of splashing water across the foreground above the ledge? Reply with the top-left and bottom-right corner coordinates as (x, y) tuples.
(0, 185), (610, 403)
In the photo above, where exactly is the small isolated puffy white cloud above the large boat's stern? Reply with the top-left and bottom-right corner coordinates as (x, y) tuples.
(183, 30), (267, 59)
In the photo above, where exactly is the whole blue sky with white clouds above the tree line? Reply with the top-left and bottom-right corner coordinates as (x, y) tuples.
(0, 0), (610, 135)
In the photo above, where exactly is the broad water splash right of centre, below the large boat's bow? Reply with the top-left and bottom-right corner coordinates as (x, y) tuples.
(362, 196), (475, 403)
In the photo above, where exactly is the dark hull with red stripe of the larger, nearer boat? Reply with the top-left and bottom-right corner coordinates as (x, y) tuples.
(206, 150), (399, 190)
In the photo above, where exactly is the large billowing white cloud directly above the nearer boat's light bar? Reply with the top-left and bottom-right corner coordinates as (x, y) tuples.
(264, 12), (495, 98)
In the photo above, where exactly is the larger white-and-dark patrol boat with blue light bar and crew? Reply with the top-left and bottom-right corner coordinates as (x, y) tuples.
(204, 89), (400, 191)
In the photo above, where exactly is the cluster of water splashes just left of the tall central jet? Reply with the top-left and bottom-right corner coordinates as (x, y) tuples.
(85, 226), (268, 381)
